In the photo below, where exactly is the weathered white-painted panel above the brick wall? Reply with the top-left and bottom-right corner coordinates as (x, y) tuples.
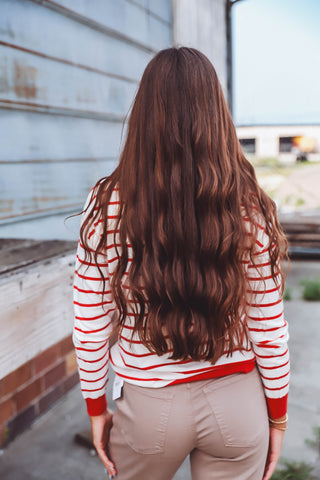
(0, 248), (74, 379)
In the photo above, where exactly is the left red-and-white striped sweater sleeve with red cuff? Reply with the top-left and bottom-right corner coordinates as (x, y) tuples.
(72, 193), (116, 416)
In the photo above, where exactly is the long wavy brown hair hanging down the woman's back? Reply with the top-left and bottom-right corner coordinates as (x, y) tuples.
(80, 47), (287, 363)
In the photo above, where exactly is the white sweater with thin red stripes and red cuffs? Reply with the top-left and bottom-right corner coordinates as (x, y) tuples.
(72, 188), (290, 418)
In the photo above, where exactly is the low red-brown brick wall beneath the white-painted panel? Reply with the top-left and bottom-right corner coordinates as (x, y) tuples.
(0, 335), (79, 446)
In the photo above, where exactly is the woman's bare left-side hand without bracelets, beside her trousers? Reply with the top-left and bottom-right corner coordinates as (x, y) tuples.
(90, 409), (117, 478)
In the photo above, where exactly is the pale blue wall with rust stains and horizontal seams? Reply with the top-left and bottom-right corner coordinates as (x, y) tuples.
(0, 0), (172, 239)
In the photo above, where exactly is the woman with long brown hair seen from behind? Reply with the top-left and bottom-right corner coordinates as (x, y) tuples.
(73, 47), (289, 480)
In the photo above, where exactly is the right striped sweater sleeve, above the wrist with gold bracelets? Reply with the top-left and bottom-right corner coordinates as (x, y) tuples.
(246, 227), (290, 419)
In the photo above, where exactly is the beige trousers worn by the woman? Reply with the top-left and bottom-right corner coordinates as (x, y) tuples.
(109, 367), (269, 480)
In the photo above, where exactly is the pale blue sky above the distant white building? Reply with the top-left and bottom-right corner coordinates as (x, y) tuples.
(232, 0), (320, 125)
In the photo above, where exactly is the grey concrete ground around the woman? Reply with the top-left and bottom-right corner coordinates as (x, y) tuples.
(0, 261), (320, 480)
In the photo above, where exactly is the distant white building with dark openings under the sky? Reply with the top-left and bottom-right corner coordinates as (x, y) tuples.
(236, 124), (320, 163)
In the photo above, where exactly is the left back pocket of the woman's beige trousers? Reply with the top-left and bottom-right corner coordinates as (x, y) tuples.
(114, 382), (173, 454)
